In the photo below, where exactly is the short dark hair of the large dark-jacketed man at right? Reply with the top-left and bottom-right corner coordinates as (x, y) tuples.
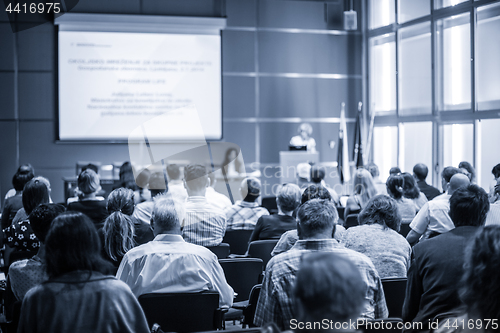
(449, 184), (490, 227)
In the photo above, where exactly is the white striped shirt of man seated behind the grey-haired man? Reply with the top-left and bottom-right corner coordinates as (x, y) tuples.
(181, 196), (226, 246)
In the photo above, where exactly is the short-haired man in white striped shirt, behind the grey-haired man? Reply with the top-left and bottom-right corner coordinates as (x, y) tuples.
(182, 164), (227, 246)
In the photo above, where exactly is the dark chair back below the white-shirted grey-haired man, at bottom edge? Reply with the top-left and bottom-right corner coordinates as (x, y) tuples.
(139, 291), (224, 332)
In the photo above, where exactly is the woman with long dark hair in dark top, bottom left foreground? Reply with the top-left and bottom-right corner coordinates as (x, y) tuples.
(18, 212), (149, 333)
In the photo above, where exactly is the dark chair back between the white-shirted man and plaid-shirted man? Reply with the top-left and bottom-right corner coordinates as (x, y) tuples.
(219, 258), (263, 302)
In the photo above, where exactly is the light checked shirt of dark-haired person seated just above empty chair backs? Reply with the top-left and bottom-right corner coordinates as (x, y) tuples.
(224, 201), (269, 230)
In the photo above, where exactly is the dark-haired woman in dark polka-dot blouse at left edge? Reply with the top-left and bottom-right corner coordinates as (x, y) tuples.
(3, 176), (52, 251)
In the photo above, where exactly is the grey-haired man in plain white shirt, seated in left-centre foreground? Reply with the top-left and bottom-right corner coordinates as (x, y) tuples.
(116, 195), (234, 307)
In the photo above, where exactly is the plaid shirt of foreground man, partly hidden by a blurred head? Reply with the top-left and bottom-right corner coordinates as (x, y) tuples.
(254, 239), (389, 330)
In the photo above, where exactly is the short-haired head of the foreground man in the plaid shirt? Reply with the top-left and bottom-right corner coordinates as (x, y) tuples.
(297, 199), (339, 238)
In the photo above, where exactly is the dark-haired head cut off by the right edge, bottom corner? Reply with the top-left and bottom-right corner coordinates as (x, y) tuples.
(461, 225), (500, 322)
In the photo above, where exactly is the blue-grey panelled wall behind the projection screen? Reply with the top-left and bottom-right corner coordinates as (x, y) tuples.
(0, 0), (362, 201)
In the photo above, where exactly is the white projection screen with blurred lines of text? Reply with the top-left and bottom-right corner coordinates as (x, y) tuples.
(55, 13), (225, 142)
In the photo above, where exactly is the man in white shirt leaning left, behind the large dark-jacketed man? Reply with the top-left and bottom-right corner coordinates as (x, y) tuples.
(406, 171), (469, 245)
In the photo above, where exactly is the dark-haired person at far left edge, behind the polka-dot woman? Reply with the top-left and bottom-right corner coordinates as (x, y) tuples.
(2, 164), (35, 230)
